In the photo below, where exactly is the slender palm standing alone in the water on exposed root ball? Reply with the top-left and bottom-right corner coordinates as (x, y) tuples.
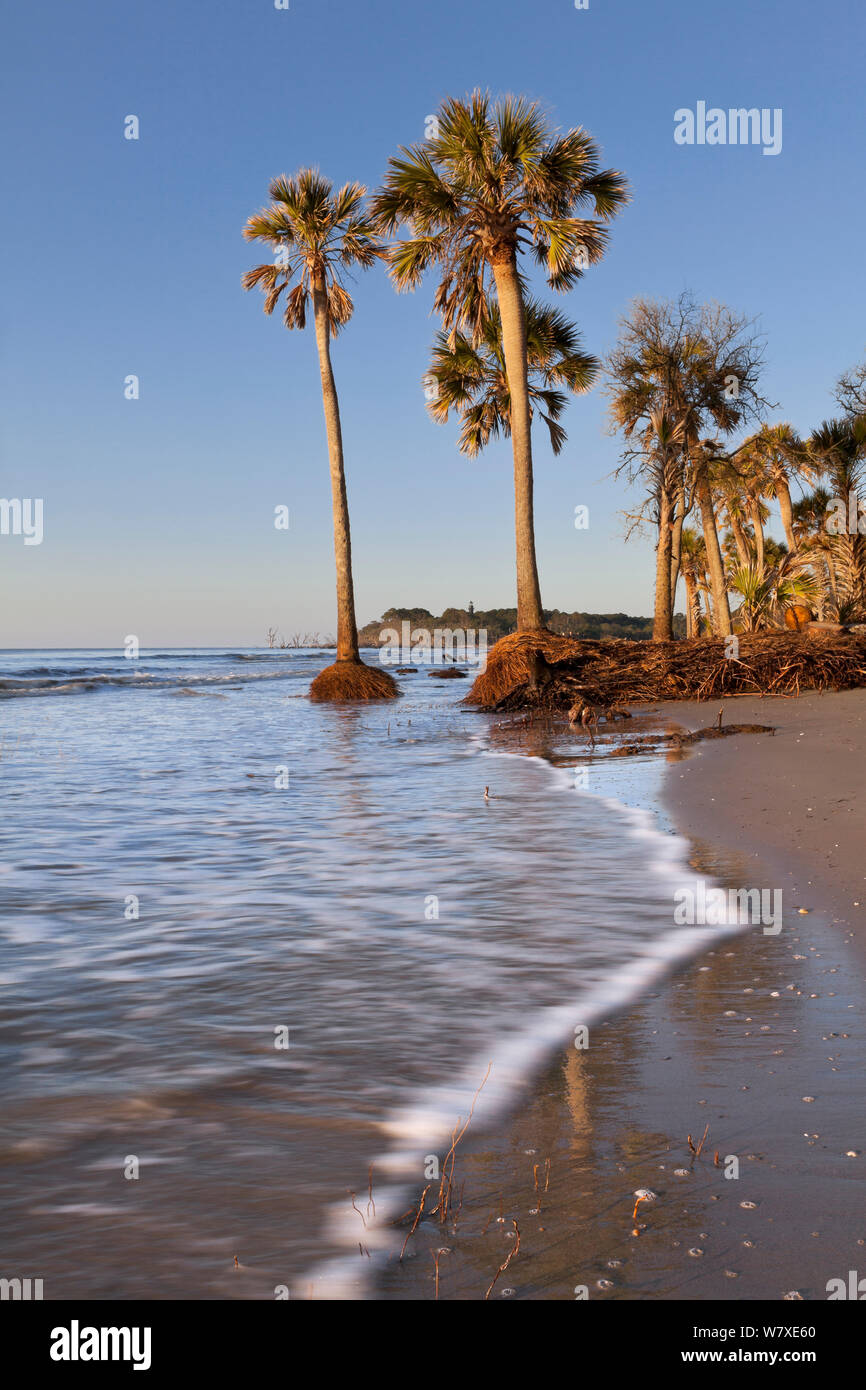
(242, 168), (398, 701)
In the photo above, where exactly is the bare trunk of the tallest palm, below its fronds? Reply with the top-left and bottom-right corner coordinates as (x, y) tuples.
(492, 250), (545, 632)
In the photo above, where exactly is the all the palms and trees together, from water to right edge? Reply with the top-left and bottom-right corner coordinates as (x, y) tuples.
(242, 90), (865, 699)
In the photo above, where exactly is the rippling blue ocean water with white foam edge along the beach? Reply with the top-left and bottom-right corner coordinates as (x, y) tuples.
(0, 648), (723, 1298)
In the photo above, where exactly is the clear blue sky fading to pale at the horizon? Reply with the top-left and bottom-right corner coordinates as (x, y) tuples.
(0, 0), (866, 648)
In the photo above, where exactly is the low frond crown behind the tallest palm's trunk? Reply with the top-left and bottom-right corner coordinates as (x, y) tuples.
(427, 299), (601, 457)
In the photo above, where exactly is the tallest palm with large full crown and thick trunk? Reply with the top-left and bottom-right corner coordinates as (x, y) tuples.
(373, 92), (627, 632)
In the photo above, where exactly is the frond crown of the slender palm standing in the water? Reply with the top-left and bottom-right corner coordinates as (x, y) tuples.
(240, 168), (385, 336)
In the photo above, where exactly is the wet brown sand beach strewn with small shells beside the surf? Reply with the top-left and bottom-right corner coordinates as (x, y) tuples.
(378, 691), (866, 1301)
